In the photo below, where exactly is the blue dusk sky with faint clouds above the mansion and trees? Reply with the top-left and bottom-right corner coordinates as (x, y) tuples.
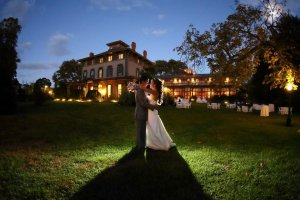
(0, 0), (300, 84)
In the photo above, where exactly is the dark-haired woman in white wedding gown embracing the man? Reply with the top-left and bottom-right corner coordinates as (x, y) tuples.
(144, 79), (175, 151)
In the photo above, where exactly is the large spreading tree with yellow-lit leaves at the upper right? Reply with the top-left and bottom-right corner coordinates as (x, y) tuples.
(175, 0), (299, 87)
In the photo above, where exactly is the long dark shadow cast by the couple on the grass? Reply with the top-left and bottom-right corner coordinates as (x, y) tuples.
(71, 148), (211, 200)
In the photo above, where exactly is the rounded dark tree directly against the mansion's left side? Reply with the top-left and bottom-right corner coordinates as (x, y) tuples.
(52, 59), (82, 85)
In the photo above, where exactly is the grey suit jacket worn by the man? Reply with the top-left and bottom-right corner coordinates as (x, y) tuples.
(135, 87), (155, 121)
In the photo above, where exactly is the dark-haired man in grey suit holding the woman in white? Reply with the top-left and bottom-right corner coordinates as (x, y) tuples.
(135, 74), (157, 152)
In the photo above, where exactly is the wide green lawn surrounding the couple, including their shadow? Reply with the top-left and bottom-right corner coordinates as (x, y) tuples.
(0, 103), (300, 200)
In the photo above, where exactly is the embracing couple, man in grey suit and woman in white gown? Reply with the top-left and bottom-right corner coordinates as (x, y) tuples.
(135, 75), (175, 152)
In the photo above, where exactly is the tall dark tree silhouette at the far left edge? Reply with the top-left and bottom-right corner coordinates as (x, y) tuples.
(0, 18), (21, 114)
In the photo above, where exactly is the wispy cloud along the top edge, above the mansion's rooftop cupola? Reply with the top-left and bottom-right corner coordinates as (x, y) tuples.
(90, 0), (153, 11)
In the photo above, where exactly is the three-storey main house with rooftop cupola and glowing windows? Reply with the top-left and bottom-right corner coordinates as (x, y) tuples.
(78, 40), (153, 100)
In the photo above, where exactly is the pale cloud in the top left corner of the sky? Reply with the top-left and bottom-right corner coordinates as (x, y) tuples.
(0, 0), (35, 21)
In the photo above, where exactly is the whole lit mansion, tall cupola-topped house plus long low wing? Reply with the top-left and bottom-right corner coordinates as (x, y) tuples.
(78, 40), (236, 100)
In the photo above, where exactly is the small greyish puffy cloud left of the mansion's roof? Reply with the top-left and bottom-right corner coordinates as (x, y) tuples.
(48, 33), (73, 56)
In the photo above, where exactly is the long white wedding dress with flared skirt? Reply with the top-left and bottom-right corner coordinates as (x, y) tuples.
(146, 95), (175, 151)
